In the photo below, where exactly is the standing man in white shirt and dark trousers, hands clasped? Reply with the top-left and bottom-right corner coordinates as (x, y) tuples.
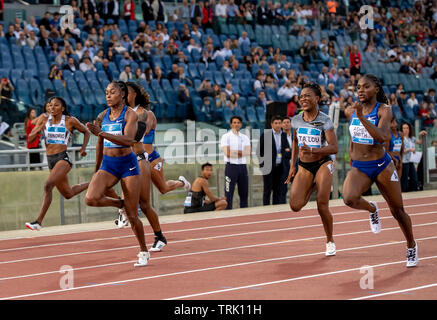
(220, 116), (252, 210)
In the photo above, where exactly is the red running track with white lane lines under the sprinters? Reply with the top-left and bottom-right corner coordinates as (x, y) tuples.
(0, 197), (437, 300)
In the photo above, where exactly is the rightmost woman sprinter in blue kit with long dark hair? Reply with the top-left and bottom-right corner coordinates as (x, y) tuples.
(343, 74), (418, 267)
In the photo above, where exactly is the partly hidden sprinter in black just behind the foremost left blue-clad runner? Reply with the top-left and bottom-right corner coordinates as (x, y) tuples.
(116, 82), (167, 251)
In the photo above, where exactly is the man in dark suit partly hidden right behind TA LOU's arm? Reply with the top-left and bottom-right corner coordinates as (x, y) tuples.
(279, 117), (293, 204)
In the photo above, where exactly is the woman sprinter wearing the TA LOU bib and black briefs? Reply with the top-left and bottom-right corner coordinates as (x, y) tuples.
(285, 83), (338, 256)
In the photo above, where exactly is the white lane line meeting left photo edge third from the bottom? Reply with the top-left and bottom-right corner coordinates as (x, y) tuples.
(0, 211), (437, 265)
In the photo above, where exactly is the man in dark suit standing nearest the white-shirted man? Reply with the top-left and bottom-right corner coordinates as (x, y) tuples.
(257, 116), (288, 205)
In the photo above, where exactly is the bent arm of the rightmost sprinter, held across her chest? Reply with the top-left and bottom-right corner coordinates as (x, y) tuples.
(353, 102), (392, 143)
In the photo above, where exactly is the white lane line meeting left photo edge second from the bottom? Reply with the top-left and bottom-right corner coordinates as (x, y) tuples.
(0, 222), (437, 281)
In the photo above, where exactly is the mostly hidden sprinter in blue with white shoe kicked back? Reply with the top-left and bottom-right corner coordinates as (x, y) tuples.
(143, 99), (191, 194)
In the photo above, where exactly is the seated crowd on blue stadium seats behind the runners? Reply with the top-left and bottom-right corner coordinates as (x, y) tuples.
(0, 0), (437, 136)
